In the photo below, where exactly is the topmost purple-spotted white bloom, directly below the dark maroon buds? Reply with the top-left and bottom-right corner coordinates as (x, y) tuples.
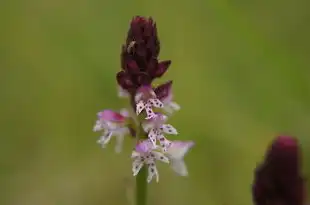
(135, 86), (164, 119)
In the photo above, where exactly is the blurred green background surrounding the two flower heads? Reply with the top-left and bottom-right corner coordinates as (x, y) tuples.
(0, 0), (310, 205)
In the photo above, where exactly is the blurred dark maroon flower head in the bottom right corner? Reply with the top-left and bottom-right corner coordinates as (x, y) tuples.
(252, 136), (306, 205)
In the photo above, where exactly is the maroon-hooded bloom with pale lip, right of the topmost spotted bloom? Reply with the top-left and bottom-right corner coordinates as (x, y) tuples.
(154, 80), (180, 114)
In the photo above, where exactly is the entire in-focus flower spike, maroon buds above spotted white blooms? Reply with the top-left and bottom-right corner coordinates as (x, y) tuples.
(94, 16), (194, 182)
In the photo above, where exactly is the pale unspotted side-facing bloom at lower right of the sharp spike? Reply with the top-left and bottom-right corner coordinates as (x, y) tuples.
(165, 141), (194, 176)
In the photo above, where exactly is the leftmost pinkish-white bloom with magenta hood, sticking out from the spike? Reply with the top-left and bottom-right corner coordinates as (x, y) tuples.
(93, 109), (130, 152)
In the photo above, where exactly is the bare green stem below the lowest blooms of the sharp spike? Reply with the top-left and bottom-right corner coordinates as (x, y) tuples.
(136, 166), (147, 205)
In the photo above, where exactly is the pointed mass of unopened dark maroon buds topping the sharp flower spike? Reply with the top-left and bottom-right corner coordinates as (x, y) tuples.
(117, 16), (171, 93)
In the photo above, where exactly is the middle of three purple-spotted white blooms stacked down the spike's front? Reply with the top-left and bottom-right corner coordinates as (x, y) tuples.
(142, 113), (178, 152)
